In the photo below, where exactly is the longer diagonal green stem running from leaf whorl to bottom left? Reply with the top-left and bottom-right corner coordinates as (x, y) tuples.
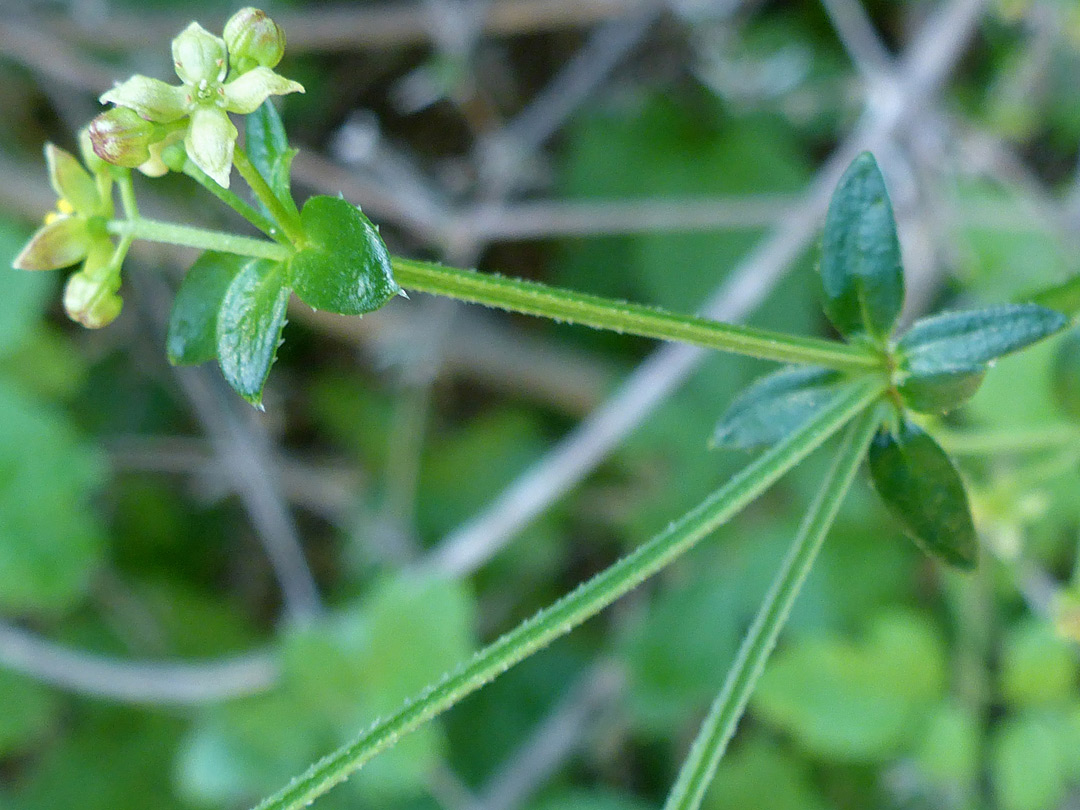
(252, 380), (883, 810)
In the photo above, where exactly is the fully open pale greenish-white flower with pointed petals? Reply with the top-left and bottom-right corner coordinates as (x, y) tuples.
(100, 23), (303, 188)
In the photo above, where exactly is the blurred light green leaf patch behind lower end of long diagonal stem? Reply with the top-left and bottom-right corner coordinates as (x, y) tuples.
(179, 579), (475, 807)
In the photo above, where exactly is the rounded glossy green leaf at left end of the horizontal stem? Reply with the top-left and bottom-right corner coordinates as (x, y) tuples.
(292, 197), (401, 315)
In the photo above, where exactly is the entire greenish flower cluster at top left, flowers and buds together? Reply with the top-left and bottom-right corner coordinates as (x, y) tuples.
(14, 9), (303, 328)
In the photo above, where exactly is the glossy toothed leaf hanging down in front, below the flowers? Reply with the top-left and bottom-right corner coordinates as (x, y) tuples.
(217, 259), (289, 405)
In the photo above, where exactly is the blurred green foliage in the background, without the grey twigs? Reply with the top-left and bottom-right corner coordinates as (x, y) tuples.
(0, 0), (1080, 810)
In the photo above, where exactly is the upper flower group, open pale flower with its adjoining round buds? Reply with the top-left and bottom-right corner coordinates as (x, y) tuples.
(90, 9), (303, 188)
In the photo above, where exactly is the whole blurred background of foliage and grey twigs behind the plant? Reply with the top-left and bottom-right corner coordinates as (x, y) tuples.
(0, 0), (1080, 810)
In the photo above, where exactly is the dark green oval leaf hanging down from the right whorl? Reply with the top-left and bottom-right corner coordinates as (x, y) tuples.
(869, 420), (978, 570)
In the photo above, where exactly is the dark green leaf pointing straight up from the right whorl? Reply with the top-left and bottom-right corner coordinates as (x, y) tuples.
(821, 152), (904, 342)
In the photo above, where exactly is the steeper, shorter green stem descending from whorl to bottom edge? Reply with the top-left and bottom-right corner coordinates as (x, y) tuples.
(664, 406), (881, 810)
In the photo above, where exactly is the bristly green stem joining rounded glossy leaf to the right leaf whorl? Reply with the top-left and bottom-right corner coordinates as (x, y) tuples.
(392, 257), (883, 370)
